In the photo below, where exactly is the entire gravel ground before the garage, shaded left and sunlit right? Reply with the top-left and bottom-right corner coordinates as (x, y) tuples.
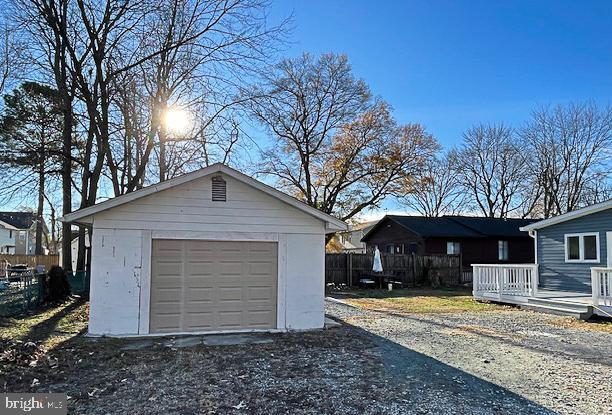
(5, 302), (612, 415)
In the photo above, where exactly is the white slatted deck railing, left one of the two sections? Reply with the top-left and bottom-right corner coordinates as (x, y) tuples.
(472, 264), (538, 300)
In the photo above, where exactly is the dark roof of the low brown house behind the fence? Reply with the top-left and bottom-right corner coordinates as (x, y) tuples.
(362, 215), (533, 242)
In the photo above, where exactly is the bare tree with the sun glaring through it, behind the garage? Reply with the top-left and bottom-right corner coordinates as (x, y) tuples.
(109, 0), (287, 192)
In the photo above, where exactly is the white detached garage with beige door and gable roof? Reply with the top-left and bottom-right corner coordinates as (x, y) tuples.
(62, 164), (346, 336)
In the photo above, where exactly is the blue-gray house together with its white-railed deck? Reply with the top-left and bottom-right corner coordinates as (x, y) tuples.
(472, 199), (612, 318)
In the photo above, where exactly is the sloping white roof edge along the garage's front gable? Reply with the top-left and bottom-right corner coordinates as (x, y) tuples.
(60, 163), (348, 231)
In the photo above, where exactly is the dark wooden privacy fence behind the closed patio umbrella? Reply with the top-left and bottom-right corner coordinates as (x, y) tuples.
(325, 253), (462, 287)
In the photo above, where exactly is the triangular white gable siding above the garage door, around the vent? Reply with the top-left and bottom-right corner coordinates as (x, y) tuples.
(94, 176), (325, 234)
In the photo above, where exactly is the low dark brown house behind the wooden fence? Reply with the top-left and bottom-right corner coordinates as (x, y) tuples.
(362, 215), (535, 268)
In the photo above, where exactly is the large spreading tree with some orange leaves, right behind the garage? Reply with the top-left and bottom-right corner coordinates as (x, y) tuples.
(249, 54), (437, 224)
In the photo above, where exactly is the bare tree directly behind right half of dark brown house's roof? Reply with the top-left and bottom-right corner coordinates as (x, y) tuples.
(457, 124), (527, 218)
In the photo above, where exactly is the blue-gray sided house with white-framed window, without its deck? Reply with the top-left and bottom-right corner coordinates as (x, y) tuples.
(523, 200), (612, 294)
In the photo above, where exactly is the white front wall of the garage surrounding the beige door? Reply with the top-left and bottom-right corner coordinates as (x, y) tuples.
(89, 175), (325, 336)
